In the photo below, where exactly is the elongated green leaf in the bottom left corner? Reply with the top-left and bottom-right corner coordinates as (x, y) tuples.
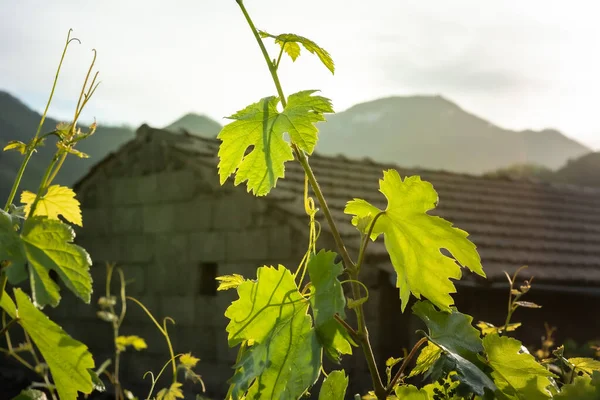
(13, 289), (94, 400)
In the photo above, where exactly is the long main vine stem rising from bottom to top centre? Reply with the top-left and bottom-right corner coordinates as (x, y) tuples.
(236, 0), (386, 400)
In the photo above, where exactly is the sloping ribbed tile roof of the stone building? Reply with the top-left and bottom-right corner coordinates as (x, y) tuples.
(76, 126), (600, 287)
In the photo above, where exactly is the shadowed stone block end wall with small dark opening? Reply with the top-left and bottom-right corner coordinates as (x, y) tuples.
(51, 165), (306, 397)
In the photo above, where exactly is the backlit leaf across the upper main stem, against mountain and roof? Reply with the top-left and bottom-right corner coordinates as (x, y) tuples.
(217, 90), (333, 196)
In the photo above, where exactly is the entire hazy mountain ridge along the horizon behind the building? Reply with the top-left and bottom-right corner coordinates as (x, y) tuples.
(0, 91), (590, 198)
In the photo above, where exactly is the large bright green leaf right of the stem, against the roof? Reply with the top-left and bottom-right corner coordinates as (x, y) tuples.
(345, 170), (485, 311)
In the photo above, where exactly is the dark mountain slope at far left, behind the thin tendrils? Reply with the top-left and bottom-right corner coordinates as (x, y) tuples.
(0, 91), (135, 197)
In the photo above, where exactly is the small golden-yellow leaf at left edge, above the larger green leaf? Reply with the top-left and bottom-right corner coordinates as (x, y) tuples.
(21, 185), (83, 226)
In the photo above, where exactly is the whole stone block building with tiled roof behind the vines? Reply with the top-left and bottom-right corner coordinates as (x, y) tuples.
(53, 125), (600, 398)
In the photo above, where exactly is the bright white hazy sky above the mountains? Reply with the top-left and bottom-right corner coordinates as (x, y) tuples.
(0, 0), (600, 149)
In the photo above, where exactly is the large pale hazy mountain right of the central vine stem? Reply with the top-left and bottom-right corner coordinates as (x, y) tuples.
(317, 96), (590, 174)
